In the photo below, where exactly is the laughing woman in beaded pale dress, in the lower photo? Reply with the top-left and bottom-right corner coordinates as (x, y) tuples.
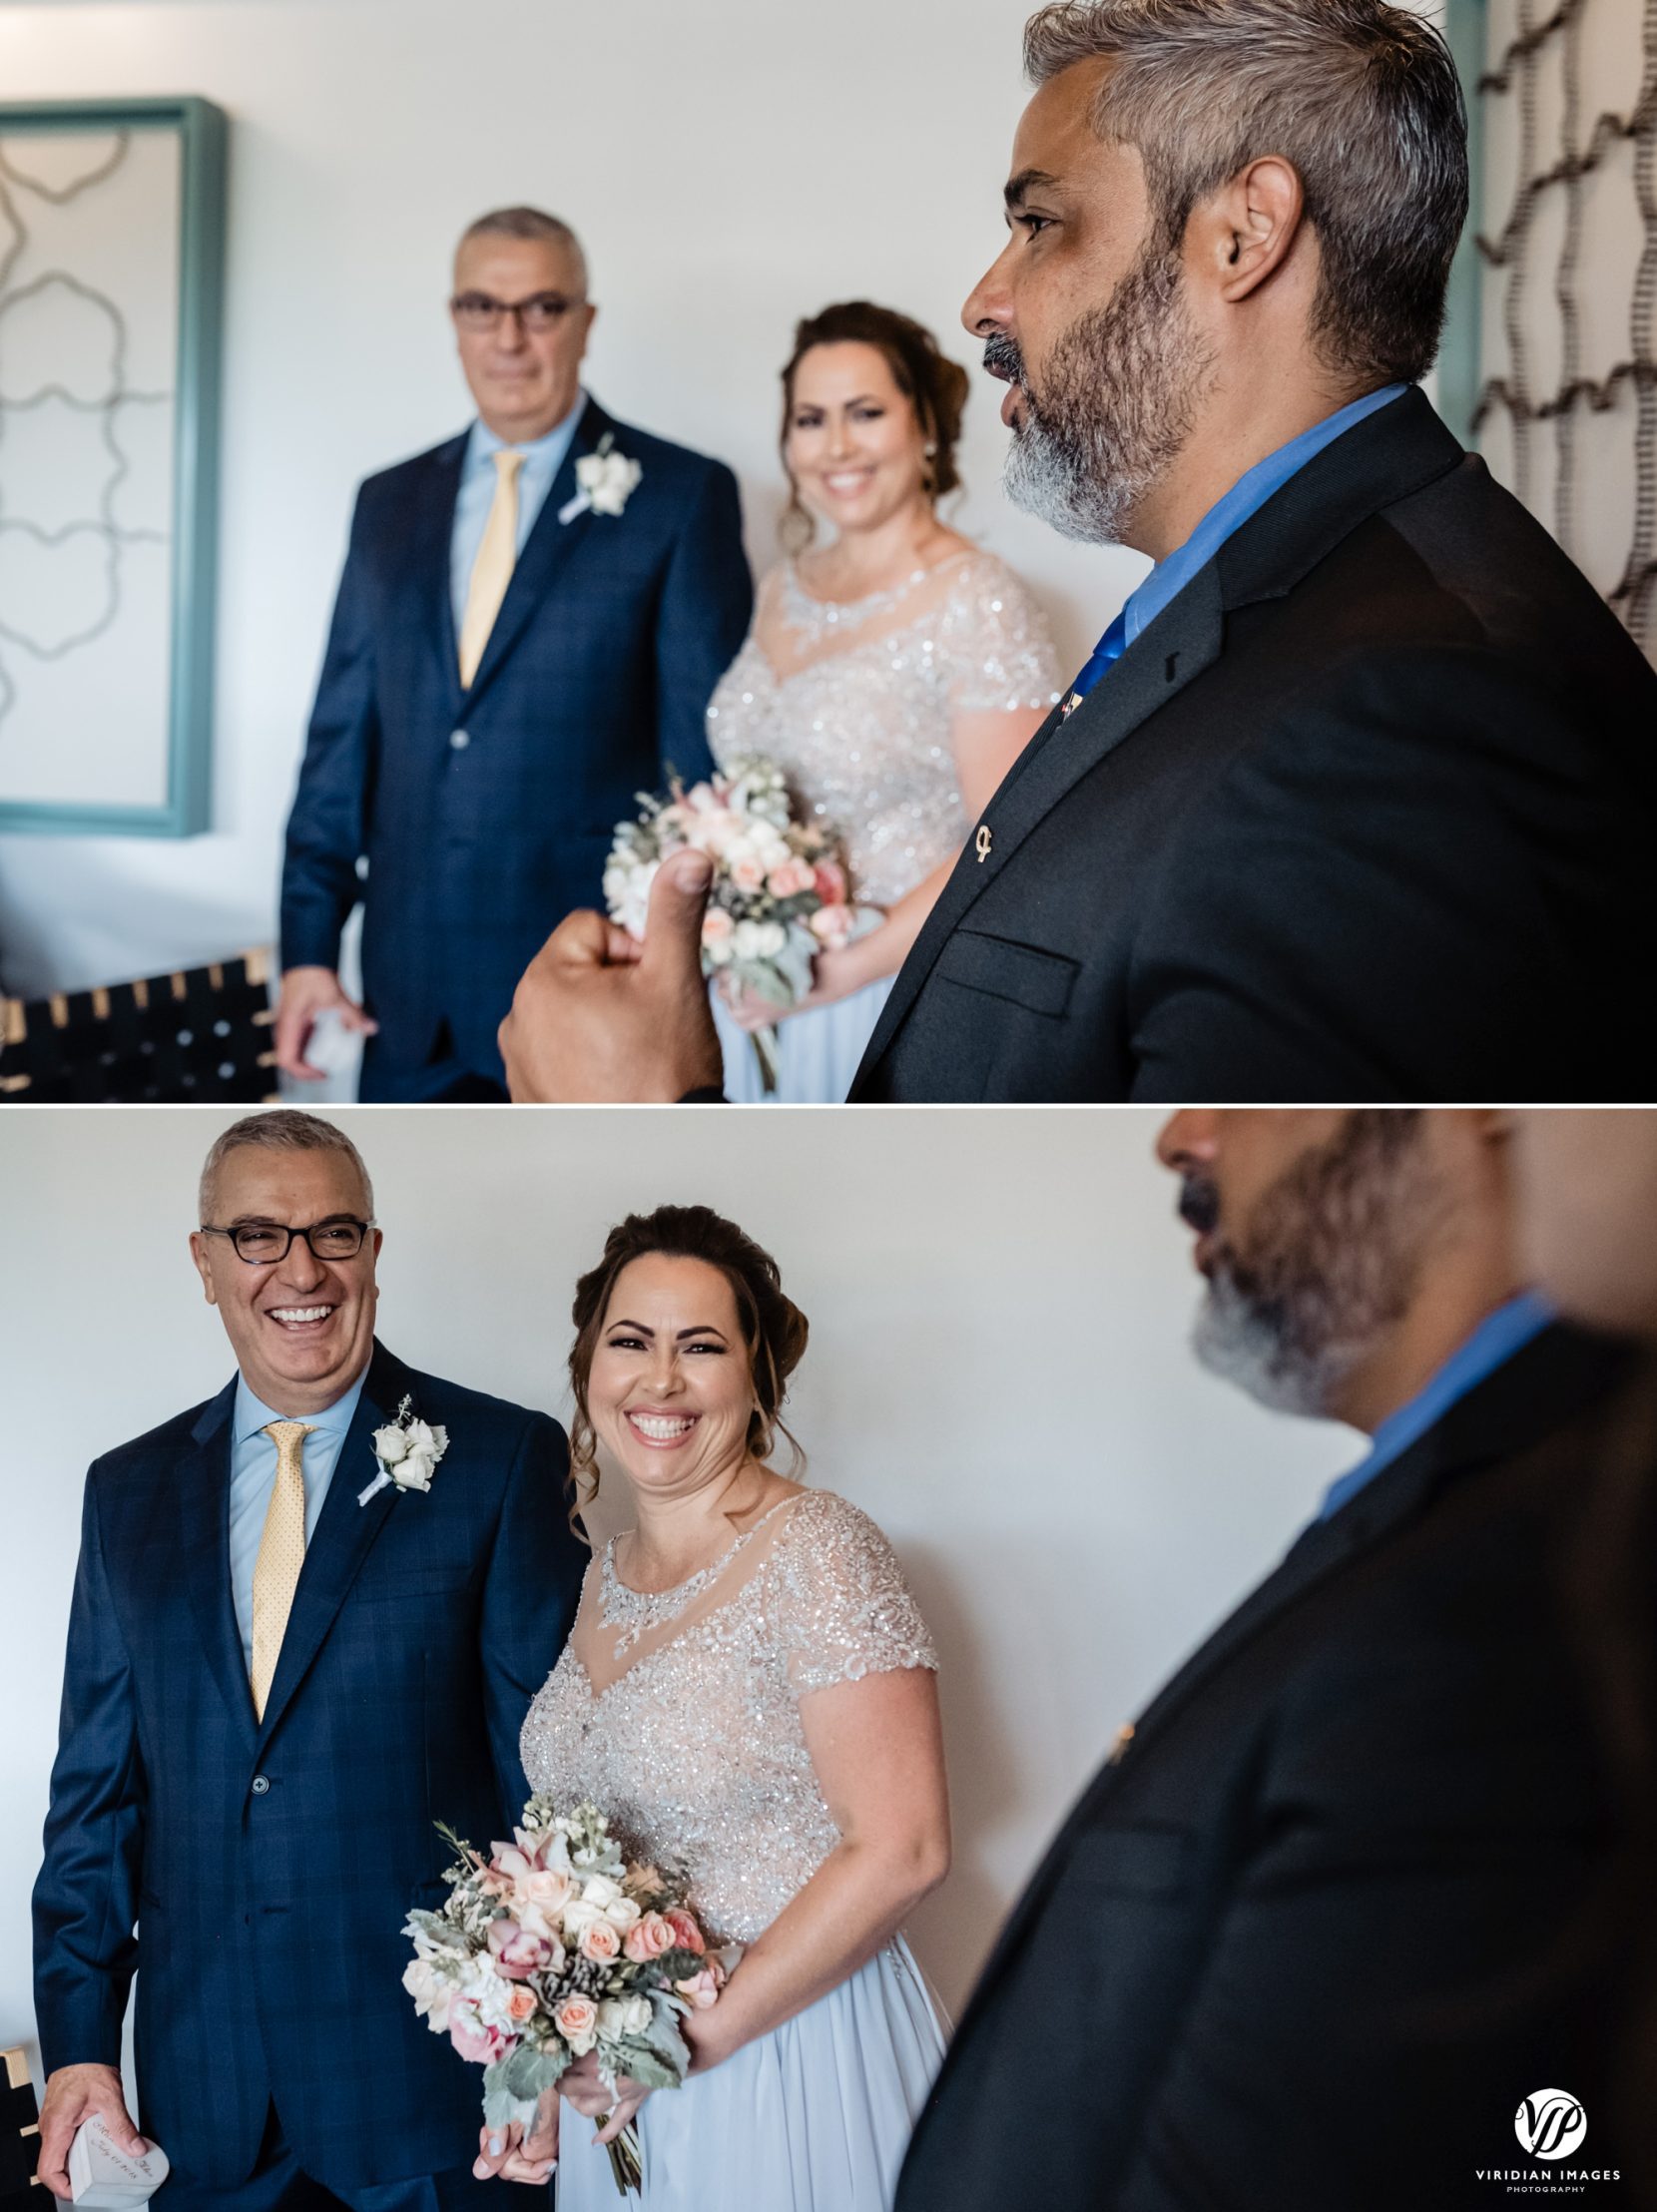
(478, 1206), (949, 2212)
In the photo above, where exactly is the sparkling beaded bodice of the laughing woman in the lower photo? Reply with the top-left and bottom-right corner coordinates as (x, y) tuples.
(522, 1491), (938, 1942)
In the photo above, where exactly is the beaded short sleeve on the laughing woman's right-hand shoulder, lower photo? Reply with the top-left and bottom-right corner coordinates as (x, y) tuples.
(772, 1491), (938, 1697)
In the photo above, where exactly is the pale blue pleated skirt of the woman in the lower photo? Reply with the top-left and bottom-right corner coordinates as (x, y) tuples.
(555, 1946), (944, 2212)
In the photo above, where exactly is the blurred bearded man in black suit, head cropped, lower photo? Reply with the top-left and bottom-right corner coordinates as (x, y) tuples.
(896, 1108), (1648, 2212)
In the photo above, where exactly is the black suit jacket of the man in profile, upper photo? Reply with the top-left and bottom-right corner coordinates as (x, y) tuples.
(851, 391), (1657, 1102)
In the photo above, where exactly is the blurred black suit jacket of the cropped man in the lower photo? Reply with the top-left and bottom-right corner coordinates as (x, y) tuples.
(896, 1330), (1628, 2212)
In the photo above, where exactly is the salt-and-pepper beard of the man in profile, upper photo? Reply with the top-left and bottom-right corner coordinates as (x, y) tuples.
(1002, 250), (1213, 544)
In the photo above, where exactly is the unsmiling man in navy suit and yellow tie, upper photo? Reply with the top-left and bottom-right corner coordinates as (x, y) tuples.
(276, 208), (753, 1102)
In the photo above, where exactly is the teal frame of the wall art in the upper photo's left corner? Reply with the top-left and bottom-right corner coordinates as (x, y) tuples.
(0, 95), (230, 836)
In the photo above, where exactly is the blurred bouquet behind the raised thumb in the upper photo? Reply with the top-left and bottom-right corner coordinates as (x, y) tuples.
(604, 759), (856, 1090)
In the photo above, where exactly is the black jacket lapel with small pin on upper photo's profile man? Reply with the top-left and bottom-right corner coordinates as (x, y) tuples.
(862, 562), (1224, 1088)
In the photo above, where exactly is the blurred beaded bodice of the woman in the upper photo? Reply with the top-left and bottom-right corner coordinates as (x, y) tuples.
(708, 553), (1057, 907)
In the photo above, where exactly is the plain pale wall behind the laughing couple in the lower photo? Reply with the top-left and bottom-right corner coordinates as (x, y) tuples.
(0, 1108), (1357, 2046)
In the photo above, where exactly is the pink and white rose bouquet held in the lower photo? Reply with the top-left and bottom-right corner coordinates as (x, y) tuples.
(402, 1796), (726, 2196)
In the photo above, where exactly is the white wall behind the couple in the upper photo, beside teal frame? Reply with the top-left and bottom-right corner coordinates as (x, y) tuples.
(0, 0), (1144, 993)
